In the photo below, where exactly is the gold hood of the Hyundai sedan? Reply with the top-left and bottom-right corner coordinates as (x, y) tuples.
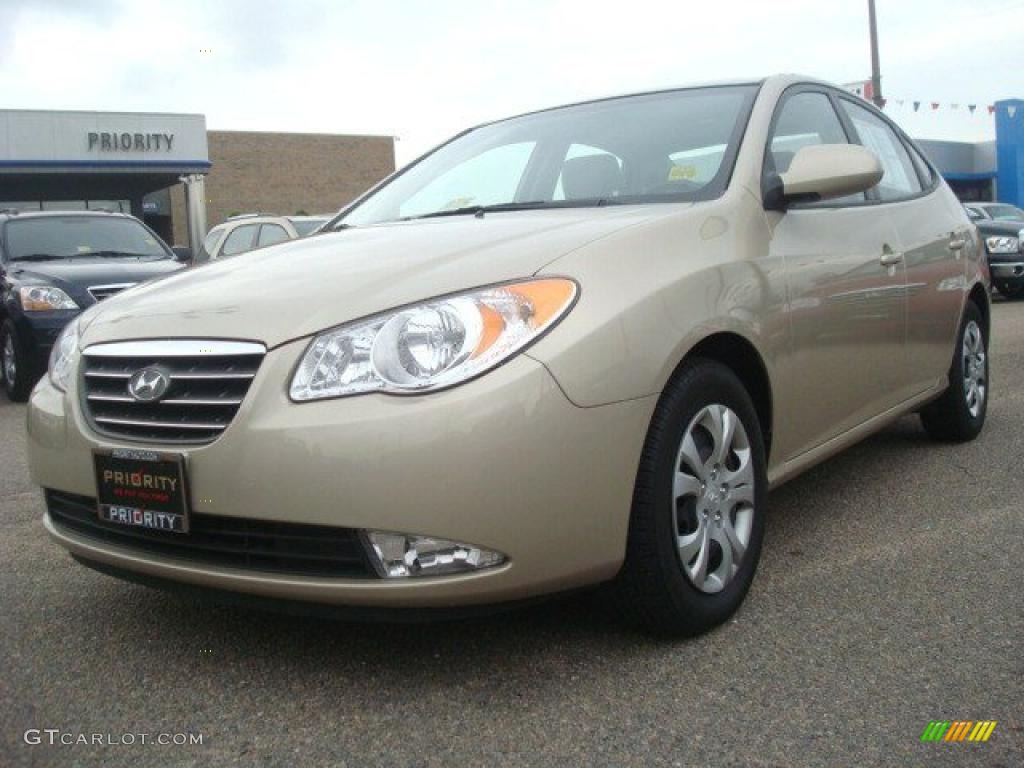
(82, 204), (685, 347)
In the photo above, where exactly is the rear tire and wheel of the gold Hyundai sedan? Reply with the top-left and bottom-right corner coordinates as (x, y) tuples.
(921, 301), (990, 442)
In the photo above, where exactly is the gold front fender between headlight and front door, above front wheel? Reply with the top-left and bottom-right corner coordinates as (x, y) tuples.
(528, 199), (788, 408)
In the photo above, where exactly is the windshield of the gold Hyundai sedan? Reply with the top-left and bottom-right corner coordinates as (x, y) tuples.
(333, 85), (757, 226)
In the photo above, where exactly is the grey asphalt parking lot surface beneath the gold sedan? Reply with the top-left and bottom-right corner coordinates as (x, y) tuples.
(0, 301), (1024, 766)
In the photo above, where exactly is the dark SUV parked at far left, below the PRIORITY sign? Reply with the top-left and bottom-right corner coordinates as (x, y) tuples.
(0, 211), (182, 401)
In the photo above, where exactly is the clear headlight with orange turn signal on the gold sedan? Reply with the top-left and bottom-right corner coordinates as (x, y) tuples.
(291, 278), (577, 401)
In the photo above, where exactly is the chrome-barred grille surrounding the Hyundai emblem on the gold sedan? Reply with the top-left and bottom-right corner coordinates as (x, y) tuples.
(81, 339), (266, 443)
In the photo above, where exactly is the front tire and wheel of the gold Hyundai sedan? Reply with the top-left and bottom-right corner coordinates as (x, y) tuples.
(618, 359), (768, 637)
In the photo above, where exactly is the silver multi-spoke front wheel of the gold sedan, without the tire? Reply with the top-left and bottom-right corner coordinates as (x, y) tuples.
(673, 404), (755, 593)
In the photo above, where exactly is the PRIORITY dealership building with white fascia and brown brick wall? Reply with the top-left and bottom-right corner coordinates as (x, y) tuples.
(0, 110), (394, 248)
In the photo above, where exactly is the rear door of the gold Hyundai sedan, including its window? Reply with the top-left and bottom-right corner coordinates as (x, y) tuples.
(840, 96), (970, 399)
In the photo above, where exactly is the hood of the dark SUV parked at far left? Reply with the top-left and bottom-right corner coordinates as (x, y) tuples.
(7, 258), (182, 306)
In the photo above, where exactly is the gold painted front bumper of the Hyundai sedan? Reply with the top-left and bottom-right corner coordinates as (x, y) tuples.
(28, 342), (656, 607)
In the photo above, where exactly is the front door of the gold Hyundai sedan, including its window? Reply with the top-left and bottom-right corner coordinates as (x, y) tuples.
(765, 86), (905, 460)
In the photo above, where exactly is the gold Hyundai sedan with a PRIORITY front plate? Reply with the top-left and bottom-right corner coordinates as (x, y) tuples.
(28, 76), (989, 635)
